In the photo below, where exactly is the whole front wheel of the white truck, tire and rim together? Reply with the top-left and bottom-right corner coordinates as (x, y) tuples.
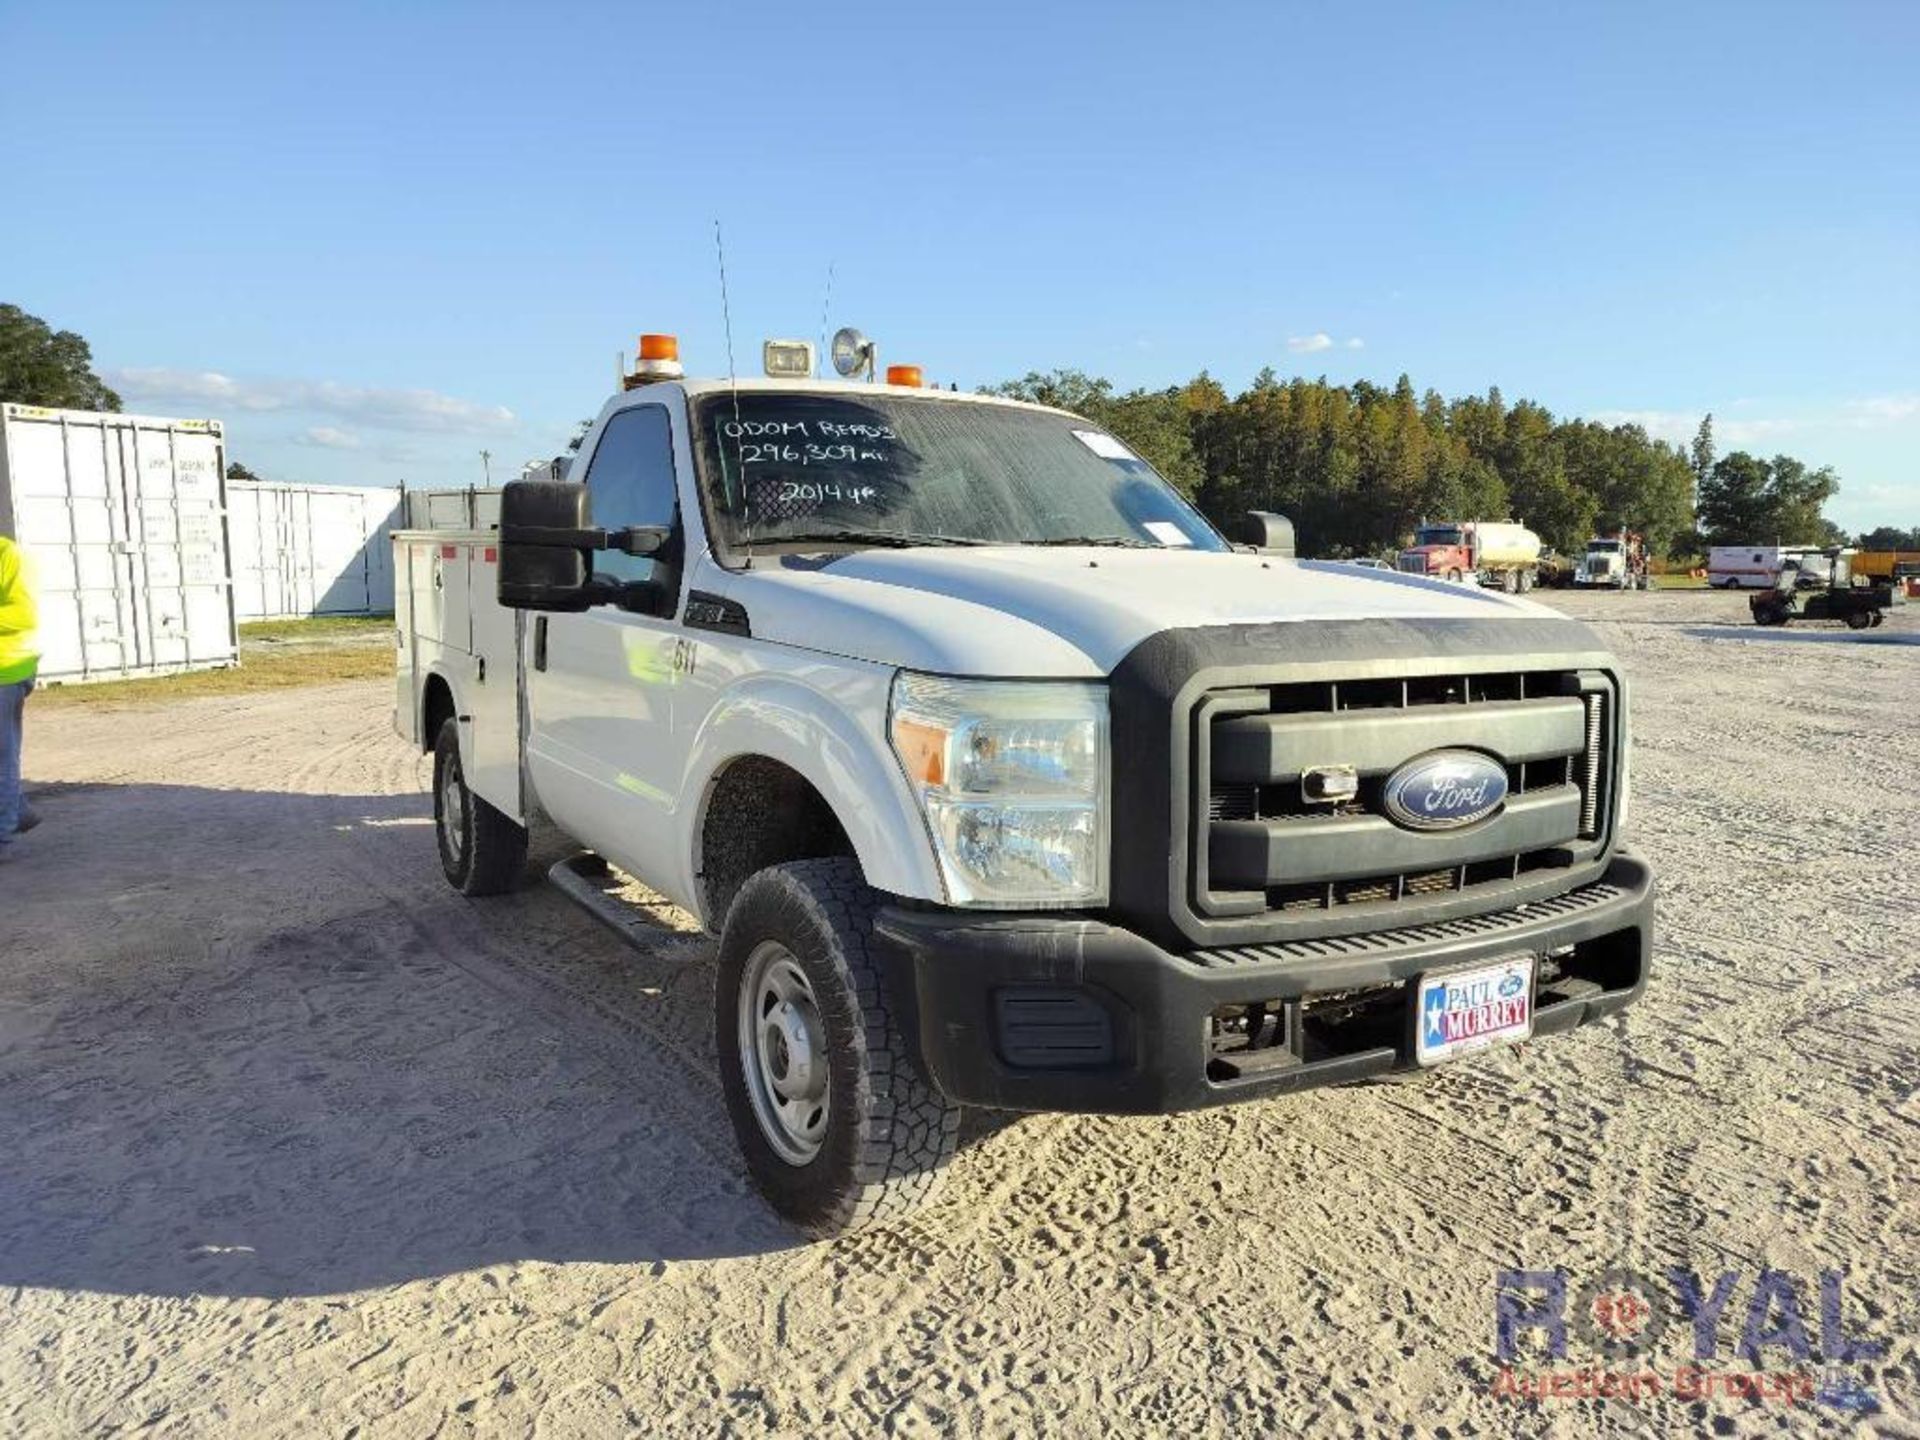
(714, 858), (960, 1236)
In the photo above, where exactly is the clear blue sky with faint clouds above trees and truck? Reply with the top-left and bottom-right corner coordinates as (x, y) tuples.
(0, 0), (1920, 528)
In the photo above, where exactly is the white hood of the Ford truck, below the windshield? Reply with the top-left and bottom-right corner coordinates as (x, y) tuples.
(724, 545), (1559, 678)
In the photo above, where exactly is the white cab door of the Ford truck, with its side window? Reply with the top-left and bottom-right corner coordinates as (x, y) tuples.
(526, 405), (684, 883)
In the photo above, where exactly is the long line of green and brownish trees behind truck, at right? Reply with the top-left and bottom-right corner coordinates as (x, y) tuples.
(989, 369), (1889, 555)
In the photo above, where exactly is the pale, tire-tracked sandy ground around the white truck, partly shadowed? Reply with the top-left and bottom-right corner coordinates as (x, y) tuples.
(0, 593), (1920, 1436)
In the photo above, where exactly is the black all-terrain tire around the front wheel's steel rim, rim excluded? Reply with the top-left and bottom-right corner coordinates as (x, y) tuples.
(714, 858), (960, 1236)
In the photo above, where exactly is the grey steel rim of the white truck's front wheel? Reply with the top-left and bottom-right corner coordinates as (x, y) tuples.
(735, 941), (833, 1165)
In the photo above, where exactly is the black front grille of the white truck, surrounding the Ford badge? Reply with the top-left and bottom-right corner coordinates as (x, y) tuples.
(1190, 670), (1617, 922)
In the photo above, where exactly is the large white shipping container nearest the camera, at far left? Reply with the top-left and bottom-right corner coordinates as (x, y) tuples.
(0, 405), (240, 682)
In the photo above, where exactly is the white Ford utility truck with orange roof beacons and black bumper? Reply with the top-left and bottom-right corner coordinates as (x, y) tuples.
(396, 344), (1653, 1233)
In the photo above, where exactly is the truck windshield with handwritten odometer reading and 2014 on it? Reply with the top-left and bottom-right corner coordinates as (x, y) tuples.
(693, 390), (1227, 551)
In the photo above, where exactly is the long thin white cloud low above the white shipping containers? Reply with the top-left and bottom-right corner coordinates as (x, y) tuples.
(111, 367), (518, 444)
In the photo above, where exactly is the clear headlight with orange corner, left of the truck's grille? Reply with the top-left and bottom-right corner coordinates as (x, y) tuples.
(887, 670), (1108, 908)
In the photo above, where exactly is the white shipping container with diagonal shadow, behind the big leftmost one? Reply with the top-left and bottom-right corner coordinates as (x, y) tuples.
(227, 480), (401, 620)
